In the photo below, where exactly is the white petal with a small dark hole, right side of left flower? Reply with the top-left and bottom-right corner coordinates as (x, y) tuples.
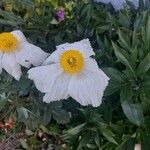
(15, 42), (48, 68)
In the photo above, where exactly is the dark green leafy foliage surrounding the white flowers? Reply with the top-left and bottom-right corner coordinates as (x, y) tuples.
(0, 0), (150, 150)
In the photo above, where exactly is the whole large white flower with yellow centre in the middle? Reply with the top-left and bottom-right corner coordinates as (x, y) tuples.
(28, 39), (109, 107)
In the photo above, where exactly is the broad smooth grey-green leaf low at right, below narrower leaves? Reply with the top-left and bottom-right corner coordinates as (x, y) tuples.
(121, 101), (144, 126)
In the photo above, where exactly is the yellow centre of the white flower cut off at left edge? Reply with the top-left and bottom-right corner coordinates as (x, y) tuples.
(0, 32), (18, 52)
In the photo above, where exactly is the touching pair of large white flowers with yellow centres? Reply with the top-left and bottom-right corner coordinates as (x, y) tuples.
(0, 31), (109, 107)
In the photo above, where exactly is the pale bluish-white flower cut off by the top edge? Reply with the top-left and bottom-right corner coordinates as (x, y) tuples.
(94, 0), (139, 11)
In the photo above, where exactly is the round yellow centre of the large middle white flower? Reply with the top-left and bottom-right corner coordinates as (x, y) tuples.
(60, 49), (84, 74)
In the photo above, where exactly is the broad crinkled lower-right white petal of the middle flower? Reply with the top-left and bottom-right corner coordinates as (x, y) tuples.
(68, 60), (109, 107)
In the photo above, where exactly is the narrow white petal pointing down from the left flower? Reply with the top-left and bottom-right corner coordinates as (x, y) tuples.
(2, 53), (22, 80)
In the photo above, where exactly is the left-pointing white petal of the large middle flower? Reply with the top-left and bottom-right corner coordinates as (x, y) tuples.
(28, 64), (63, 93)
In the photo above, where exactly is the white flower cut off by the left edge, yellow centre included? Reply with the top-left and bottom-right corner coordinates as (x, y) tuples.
(0, 30), (48, 80)
